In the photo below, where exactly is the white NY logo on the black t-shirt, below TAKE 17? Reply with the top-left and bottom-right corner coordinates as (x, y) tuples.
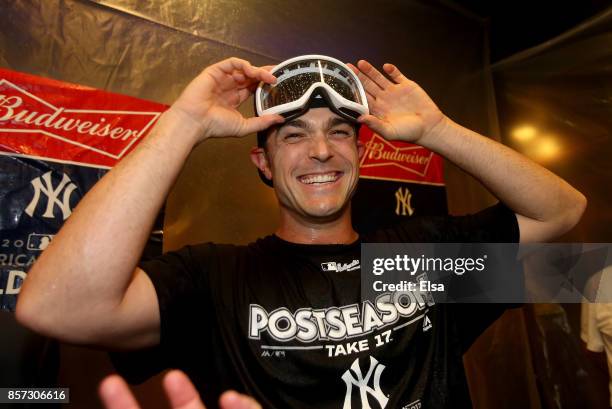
(342, 356), (389, 409)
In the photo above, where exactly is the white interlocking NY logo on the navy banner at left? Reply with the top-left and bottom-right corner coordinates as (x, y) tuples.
(25, 171), (77, 220)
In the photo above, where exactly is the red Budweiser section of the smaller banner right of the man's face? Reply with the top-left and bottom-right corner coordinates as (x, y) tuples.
(359, 126), (444, 186)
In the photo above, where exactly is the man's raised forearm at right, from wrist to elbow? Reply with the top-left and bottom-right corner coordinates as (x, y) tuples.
(419, 118), (586, 233)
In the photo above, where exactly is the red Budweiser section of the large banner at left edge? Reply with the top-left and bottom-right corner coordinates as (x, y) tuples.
(0, 69), (167, 168)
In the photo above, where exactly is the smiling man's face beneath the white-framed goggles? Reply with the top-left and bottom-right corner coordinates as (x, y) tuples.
(252, 108), (363, 221)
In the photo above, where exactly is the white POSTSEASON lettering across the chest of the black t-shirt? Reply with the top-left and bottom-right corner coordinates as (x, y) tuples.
(249, 291), (434, 342)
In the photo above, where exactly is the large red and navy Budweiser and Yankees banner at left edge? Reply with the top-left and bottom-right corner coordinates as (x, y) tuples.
(0, 69), (166, 311)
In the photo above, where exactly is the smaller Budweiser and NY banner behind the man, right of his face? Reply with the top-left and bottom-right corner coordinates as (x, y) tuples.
(352, 126), (447, 232)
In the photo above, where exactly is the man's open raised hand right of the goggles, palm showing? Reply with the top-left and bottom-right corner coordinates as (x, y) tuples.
(348, 60), (446, 143)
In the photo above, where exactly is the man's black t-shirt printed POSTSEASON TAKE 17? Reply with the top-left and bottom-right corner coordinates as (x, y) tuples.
(114, 204), (519, 409)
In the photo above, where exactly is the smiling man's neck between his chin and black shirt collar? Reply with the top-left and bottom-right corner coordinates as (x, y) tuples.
(276, 206), (359, 244)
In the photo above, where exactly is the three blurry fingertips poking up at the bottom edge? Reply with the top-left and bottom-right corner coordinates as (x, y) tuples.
(99, 370), (261, 409)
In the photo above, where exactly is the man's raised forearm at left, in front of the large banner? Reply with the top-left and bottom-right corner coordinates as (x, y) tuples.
(18, 109), (200, 322)
